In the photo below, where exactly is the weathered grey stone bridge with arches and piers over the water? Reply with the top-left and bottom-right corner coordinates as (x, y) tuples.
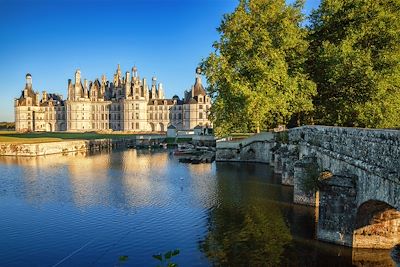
(282, 126), (400, 248)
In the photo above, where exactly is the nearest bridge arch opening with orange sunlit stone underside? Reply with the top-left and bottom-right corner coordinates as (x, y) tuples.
(353, 200), (400, 249)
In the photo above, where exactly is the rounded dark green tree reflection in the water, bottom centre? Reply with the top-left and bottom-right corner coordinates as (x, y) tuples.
(200, 198), (291, 266)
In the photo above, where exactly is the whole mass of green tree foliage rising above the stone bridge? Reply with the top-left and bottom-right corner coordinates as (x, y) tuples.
(202, 0), (400, 135)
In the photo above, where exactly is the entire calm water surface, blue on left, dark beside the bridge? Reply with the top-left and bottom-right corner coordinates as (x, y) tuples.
(0, 150), (393, 266)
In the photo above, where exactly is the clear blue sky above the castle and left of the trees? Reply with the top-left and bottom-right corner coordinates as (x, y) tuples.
(0, 0), (320, 121)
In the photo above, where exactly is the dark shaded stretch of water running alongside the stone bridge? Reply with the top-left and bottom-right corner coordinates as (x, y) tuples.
(199, 163), (396, 266)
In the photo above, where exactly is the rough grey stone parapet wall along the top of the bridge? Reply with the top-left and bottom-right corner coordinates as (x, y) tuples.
(289, 126), (400, 182)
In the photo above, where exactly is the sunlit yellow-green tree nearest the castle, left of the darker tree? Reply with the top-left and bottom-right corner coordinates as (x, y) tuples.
(202, 0), (316, 135)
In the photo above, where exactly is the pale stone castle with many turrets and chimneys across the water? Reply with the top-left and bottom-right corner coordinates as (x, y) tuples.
(14, 65), (212, 132)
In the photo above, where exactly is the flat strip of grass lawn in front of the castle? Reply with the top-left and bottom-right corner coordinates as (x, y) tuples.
(0, 131), (157, 144)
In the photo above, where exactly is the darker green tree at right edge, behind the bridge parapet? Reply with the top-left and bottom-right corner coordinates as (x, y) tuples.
(308, 0), (400, 128)
